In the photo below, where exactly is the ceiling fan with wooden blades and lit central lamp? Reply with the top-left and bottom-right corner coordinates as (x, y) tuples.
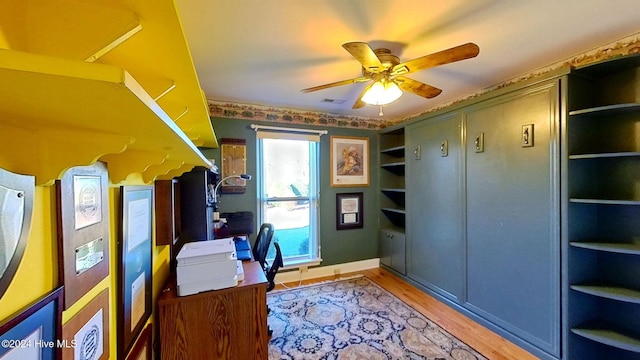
(302, 42), (480, 114)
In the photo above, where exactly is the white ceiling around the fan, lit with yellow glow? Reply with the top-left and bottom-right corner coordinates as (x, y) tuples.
(176, 0), (640, 119)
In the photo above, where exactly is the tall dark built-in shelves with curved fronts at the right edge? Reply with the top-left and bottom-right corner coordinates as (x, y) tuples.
(565, 55), (640, 360)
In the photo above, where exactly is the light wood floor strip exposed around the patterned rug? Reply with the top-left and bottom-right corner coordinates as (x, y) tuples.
(276, 268), (537, 360)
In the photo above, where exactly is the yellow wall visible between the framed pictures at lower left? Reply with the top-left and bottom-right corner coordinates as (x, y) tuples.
(0, 176), (170, 359)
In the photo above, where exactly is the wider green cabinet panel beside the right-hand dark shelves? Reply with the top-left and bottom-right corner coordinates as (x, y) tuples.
(464, 81), (561, 356)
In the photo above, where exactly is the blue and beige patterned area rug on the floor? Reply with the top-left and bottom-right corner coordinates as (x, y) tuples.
(267, 277), (485, 360)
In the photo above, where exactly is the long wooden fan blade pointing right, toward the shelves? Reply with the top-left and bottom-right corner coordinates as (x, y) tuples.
(391, 43), (480, 76)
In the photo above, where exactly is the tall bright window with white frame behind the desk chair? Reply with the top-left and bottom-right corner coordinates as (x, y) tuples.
(257, 131), (321, 267)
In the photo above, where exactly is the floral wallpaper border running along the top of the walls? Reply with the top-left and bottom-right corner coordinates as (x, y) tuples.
(207, 33), (640, 130)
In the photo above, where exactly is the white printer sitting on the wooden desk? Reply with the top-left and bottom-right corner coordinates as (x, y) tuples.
(176, 238), (238, 296)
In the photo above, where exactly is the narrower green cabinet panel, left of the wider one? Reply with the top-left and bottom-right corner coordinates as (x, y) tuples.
(406, 112), (465, 302)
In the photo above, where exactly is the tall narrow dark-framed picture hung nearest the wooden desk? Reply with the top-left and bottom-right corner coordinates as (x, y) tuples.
(117, 186), (153, 359)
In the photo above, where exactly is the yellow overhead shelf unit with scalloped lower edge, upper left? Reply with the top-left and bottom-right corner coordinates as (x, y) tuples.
(0, 0), (218, 185)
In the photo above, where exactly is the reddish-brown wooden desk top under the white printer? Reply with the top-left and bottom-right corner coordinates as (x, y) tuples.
(158, 261), (267, 305)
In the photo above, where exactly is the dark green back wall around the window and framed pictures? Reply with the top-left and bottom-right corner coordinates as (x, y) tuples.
(203, 118), (380, 266)
